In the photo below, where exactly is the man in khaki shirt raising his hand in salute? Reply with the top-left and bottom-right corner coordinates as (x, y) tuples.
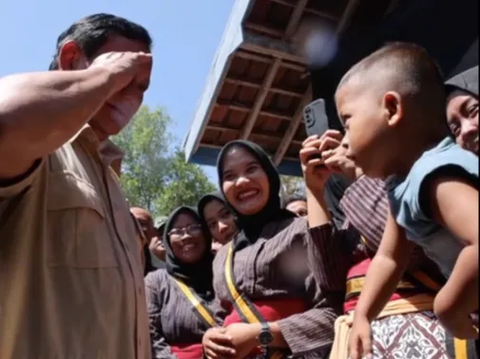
(0, 14), (152, 359)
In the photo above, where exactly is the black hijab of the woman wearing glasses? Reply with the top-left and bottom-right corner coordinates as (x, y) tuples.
(163, 207), (214, 300)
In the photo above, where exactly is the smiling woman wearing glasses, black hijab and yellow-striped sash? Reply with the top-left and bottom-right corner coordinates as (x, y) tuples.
(145, 207), (226, 359)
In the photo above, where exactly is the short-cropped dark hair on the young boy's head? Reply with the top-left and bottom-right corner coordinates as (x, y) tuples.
(337, 42), (446, 118)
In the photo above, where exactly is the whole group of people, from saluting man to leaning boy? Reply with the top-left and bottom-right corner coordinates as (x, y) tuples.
(0, 14), (479, 359)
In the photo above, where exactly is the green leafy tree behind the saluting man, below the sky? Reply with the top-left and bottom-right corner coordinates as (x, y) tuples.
(113, 106), (213, 216)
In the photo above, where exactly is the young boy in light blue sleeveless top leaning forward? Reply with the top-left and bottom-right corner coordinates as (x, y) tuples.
(336, 43), (478, 359)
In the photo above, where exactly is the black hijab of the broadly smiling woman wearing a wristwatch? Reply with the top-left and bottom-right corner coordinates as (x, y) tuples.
(217, 140), (296, 250)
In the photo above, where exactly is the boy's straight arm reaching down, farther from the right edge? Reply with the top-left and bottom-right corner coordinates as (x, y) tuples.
(349, 213), (414, 359)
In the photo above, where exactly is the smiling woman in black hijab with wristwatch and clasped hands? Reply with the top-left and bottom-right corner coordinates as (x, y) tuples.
(203, 141), (336, 359)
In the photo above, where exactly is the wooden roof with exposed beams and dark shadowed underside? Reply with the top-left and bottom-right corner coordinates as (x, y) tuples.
(184, 0), (478, 175)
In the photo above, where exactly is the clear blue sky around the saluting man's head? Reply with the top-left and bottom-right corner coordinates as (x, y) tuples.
(0, 0), (234, 178)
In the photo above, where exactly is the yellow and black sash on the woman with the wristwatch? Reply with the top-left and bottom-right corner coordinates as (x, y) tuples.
(225, 243), (284, 359)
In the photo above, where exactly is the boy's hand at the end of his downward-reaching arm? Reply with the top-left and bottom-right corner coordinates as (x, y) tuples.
(348, 317), (373, 359)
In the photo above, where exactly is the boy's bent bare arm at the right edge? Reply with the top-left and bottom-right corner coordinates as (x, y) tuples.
(429, 177), (478, 338)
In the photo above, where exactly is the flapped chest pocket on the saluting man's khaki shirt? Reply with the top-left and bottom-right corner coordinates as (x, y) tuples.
(47, 172), (117, 268)
